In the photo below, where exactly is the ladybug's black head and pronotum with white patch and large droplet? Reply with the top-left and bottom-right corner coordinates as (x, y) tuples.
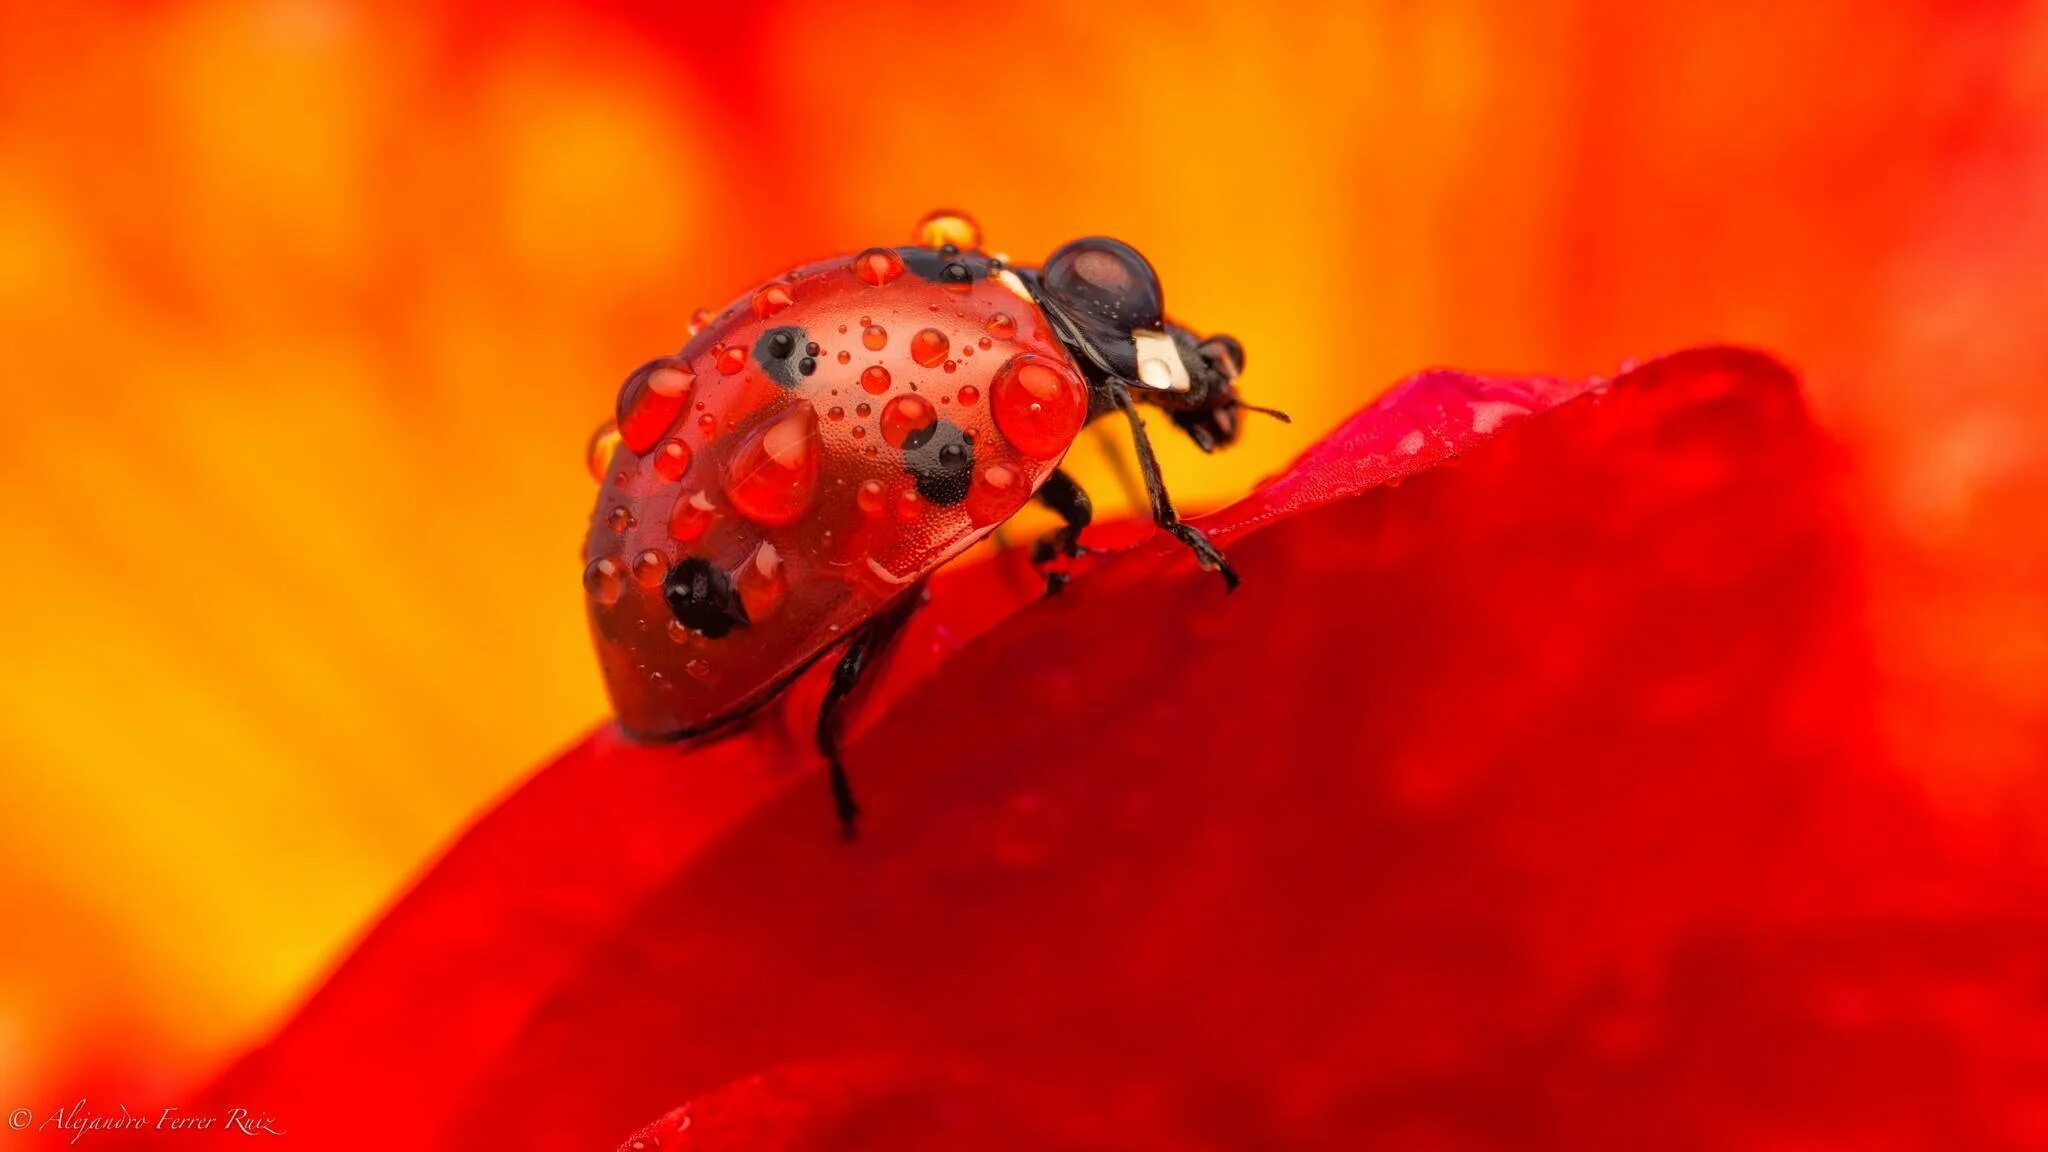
(1036, 236), (1286, 451)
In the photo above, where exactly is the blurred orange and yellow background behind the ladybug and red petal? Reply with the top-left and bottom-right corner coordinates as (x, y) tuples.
(0, 0), (2048, 1107)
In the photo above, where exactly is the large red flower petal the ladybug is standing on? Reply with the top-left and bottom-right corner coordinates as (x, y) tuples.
(180, 351), (2048, 1148)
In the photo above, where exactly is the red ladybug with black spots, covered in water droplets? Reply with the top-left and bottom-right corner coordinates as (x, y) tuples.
(584, 213), (1268, 836)
